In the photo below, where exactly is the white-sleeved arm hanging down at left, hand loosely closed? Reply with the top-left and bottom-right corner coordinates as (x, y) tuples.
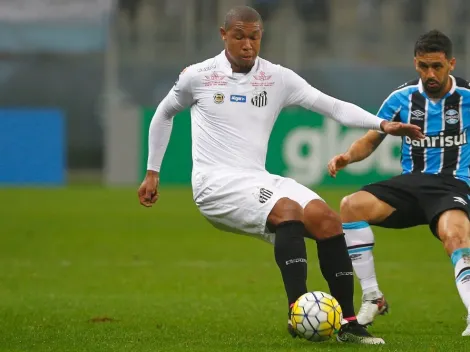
(138, 70), (194, 207)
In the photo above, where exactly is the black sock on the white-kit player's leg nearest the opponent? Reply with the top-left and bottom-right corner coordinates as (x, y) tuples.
(317, 234), (356, 321)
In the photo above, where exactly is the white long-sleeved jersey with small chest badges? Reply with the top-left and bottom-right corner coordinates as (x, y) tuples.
(148, 52), (383, 174)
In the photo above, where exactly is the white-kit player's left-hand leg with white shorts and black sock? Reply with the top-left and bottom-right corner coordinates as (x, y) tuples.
(195, 171), (307, 336)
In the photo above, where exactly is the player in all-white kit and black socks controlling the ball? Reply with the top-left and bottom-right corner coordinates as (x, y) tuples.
(138, 6), (422, 344)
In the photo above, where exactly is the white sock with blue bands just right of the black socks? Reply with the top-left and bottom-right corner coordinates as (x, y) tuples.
(343, 221), (380, 295)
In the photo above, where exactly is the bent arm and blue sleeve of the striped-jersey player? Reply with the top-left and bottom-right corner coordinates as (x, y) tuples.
(328, 94), (400, 177)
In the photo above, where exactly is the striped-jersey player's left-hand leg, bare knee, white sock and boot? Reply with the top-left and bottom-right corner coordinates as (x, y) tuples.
(340, 191), (395, 325)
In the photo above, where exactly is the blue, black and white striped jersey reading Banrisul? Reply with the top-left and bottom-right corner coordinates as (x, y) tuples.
(377, 76), (470, 184)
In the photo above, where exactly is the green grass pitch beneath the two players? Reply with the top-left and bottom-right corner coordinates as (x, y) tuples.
(0, 187), (470, 352)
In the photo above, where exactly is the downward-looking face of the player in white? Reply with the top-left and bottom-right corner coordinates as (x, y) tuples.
(220, 21), (263, 72)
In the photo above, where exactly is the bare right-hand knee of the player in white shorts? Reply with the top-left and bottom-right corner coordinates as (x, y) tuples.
(304, 200), (343, 239)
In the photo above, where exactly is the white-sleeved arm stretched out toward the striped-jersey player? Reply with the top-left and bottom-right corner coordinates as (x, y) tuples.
(283, 68), (424, 139)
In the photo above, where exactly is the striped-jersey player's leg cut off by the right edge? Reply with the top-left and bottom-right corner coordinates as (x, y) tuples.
(436, 209), (470, 336)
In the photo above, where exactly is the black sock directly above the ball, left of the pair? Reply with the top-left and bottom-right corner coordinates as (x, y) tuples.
(274, 221), (308, 306)
